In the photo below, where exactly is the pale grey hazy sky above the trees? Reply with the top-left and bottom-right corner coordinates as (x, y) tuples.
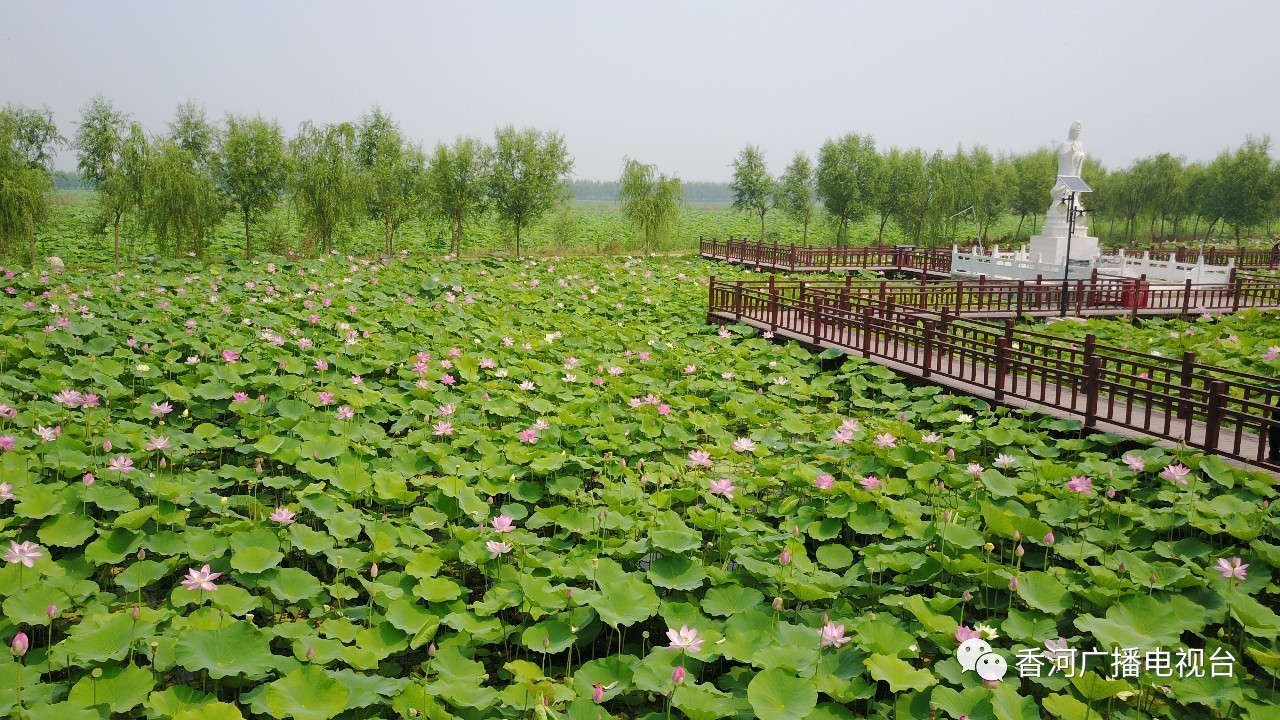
(0, 0), (1280, 181)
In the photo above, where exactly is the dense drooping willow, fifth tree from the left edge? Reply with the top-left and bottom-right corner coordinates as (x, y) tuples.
(289, 120), (365, 252)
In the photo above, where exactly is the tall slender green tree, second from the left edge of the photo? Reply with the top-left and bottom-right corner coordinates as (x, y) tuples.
(74, 95), (147, 263)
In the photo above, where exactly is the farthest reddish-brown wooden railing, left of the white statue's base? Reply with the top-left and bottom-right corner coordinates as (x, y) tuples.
(698, 237), (951, 274)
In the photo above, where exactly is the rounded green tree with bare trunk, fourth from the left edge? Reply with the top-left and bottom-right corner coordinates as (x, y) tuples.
(215, 115), (285, 259)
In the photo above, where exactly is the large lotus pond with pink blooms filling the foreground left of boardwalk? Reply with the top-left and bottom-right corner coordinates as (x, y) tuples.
(0, 252), (1280, 720)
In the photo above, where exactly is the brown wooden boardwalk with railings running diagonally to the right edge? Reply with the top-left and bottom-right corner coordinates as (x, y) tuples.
(709, 278), (1280, 469)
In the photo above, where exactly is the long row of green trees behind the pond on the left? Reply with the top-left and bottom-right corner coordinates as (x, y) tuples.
(0, 95), (573, 261)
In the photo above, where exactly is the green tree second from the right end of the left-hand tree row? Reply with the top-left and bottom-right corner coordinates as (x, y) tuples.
(426, 137), (492, 258)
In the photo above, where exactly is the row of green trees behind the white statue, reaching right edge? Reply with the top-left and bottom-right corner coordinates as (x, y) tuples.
(730, 133), (1280, 245)
